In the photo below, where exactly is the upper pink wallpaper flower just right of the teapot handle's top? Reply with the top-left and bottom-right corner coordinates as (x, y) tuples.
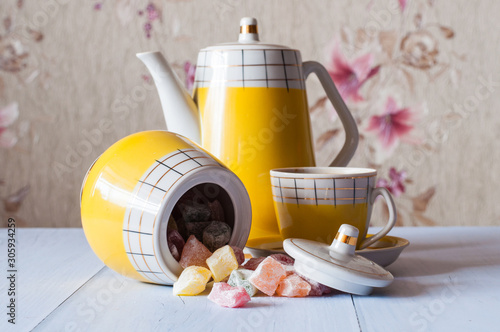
(328, 44), (380, 102)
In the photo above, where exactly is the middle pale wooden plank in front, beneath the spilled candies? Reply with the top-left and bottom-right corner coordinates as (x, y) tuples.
(35, 268), (359, 332)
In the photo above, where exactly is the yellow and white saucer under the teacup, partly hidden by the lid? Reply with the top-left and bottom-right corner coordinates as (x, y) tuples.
(245, 234), (410, 267)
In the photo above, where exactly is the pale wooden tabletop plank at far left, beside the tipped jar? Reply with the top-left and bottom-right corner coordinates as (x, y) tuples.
(0, 228), (104, 331)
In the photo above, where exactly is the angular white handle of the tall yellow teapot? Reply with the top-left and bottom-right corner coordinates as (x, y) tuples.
(302, 61), (359, 166)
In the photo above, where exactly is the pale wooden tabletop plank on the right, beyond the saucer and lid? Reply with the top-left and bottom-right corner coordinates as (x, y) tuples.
(353, 227), (500, 331)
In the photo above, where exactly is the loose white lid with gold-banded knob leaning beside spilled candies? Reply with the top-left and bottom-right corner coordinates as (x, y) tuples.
(283, 224), (394, 295)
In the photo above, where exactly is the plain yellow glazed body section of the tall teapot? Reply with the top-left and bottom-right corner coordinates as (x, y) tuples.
(194, 86), (315, 247)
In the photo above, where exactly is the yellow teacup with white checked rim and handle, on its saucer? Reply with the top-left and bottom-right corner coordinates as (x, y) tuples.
(271, 167), (396, 249)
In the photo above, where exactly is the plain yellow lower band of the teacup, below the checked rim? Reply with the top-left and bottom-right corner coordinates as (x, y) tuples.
(274, 201), (369, 249)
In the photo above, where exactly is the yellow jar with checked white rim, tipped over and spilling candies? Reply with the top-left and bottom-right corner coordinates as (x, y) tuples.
(80, 131), (252, 285)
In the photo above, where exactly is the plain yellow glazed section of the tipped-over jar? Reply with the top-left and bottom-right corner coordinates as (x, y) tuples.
(81, 131), (193, 281)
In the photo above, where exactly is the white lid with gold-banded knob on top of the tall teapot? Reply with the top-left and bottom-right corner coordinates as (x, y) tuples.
(201, 17), (292, 52)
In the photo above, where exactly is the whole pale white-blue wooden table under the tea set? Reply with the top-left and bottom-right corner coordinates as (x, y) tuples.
(0, 227), (500, 331)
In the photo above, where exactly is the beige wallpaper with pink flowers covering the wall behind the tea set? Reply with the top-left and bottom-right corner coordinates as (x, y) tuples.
(0, 0), (500, 227)
